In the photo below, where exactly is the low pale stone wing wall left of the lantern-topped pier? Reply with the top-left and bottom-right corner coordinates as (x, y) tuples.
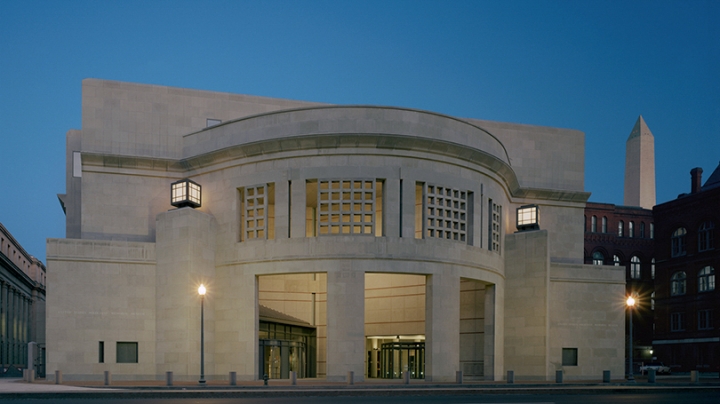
(46, 239), (156, 380)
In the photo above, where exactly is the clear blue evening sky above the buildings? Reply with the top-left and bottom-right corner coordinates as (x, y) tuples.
(0, 0), (720, 261)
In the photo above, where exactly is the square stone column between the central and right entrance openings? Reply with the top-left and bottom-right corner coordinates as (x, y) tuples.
(425, 273), (460, 382)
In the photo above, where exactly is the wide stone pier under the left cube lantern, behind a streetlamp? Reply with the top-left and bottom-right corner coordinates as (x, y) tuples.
(155, 208), (221, 380)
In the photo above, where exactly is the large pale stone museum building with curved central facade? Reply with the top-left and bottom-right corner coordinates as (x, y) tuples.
(47, 79), (625, 381)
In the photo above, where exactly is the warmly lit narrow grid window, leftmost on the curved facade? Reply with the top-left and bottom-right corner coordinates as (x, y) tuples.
(240, 184), (275, 241)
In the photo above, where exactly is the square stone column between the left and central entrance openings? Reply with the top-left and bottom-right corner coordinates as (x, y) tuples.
(327, 263), (366, 382)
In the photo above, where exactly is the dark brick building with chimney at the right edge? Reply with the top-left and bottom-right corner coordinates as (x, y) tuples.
(653, 166), (720, 372)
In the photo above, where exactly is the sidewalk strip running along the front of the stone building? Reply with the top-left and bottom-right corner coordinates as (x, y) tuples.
(0, 375), (720, 399)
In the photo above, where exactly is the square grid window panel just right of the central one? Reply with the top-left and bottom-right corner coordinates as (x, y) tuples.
(425, 185), (468, 242)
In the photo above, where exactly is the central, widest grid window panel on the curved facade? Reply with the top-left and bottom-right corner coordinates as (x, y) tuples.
(317, 179), (376, 235)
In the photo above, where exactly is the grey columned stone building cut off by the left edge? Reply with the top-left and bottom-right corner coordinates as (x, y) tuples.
(0, 223), (46, 377)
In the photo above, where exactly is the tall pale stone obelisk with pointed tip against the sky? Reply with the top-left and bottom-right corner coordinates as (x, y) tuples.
(623, 115), (655, 209)
